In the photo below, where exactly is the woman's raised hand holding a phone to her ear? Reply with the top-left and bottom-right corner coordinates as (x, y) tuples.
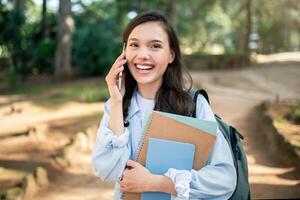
(105, 52), (126, 102)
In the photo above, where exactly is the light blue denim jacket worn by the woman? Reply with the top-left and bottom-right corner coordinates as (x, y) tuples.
(92, 91), (236, 200)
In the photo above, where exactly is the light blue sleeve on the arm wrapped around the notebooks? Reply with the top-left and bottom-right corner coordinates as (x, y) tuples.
(165, 95), (236, 199)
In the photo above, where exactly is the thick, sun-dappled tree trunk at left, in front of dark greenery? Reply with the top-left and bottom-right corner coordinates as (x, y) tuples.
(55, 0), (74, 79)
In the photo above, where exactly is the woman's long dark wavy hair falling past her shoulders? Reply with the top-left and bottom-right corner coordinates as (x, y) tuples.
(123, 11), (195, 119)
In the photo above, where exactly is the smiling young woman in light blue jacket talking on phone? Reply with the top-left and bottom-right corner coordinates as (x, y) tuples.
(93, 11), (236, 199)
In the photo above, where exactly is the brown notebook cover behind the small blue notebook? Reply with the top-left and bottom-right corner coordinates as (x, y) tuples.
(123, 112), (216, 200)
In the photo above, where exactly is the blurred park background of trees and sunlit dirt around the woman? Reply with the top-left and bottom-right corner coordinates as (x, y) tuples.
(0, 0), (300, 200)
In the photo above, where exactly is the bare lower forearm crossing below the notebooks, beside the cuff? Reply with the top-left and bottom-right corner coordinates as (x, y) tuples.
(147, 174), (177, 196)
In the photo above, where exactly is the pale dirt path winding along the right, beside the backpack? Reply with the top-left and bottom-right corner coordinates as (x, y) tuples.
(192, 64), (300, 199)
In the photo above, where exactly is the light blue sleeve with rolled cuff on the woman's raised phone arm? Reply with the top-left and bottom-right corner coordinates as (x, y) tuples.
(92, 101), (129, 182)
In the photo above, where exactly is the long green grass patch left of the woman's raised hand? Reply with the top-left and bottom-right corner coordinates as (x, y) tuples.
(1, 78), (110, 107)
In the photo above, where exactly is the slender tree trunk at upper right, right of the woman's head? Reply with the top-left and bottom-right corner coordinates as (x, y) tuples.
(240, 0), (252, 55)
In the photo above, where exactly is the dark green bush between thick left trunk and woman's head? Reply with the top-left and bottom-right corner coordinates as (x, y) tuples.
(72, 20), (121, 76)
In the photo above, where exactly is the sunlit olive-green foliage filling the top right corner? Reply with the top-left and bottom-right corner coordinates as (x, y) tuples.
(254, 0), (300, 53)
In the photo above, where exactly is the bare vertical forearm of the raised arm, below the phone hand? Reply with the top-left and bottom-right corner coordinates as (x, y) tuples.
(108, 101), (124, 136)
